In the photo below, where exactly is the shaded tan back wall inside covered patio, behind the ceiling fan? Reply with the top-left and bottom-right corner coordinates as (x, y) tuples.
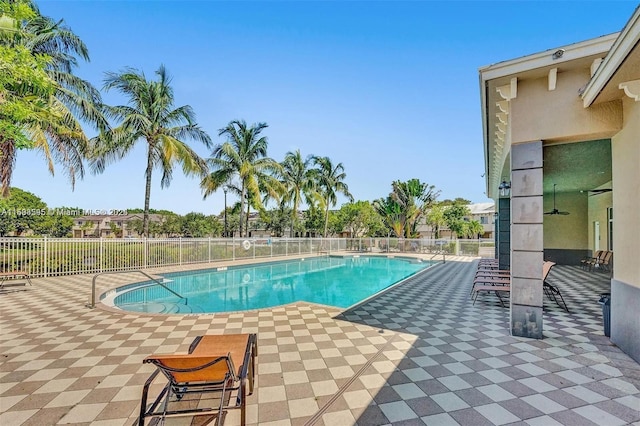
(543, 192), (589, 250)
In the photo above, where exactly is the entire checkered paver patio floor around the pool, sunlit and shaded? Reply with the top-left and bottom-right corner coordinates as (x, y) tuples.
(0, 258), (640, 426)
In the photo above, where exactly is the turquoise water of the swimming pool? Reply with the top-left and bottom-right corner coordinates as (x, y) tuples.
(113, 256), (432, 313)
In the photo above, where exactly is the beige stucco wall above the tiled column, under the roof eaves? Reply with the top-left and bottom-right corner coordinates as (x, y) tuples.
(509, 68), (622, 144)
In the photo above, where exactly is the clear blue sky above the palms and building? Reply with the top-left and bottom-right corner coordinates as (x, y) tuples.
(13, 1), (638, 214)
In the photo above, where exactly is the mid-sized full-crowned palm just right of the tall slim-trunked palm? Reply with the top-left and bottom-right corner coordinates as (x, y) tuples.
(200, 120), (281, 237)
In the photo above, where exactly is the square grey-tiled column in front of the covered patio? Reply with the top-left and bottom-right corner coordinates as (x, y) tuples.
(510, 141), (544, 339)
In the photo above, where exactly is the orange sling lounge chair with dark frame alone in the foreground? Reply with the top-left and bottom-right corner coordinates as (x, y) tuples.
(138, 334), (257, 426)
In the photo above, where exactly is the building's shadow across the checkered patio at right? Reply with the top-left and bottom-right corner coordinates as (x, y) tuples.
(306, 262), (640, 425)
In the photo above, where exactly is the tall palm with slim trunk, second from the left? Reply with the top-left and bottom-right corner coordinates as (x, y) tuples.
(91, 65), (211, 237)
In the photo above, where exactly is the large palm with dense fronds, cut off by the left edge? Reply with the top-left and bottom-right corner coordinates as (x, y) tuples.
(0, 0), (107, 196)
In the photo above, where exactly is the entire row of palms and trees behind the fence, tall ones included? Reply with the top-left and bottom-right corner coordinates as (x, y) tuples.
(0, 0), (480, 238)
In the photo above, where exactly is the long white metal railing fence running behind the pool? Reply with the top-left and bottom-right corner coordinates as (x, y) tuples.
(0, 237), (493, 277)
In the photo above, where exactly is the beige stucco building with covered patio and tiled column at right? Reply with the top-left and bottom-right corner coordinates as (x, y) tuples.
(479, 9), (640, 361)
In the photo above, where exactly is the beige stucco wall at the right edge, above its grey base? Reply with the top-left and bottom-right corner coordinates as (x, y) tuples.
(611, 96), (640, 287)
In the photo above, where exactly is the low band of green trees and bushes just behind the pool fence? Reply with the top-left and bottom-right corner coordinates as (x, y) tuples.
(0, 186), (483, 238)
